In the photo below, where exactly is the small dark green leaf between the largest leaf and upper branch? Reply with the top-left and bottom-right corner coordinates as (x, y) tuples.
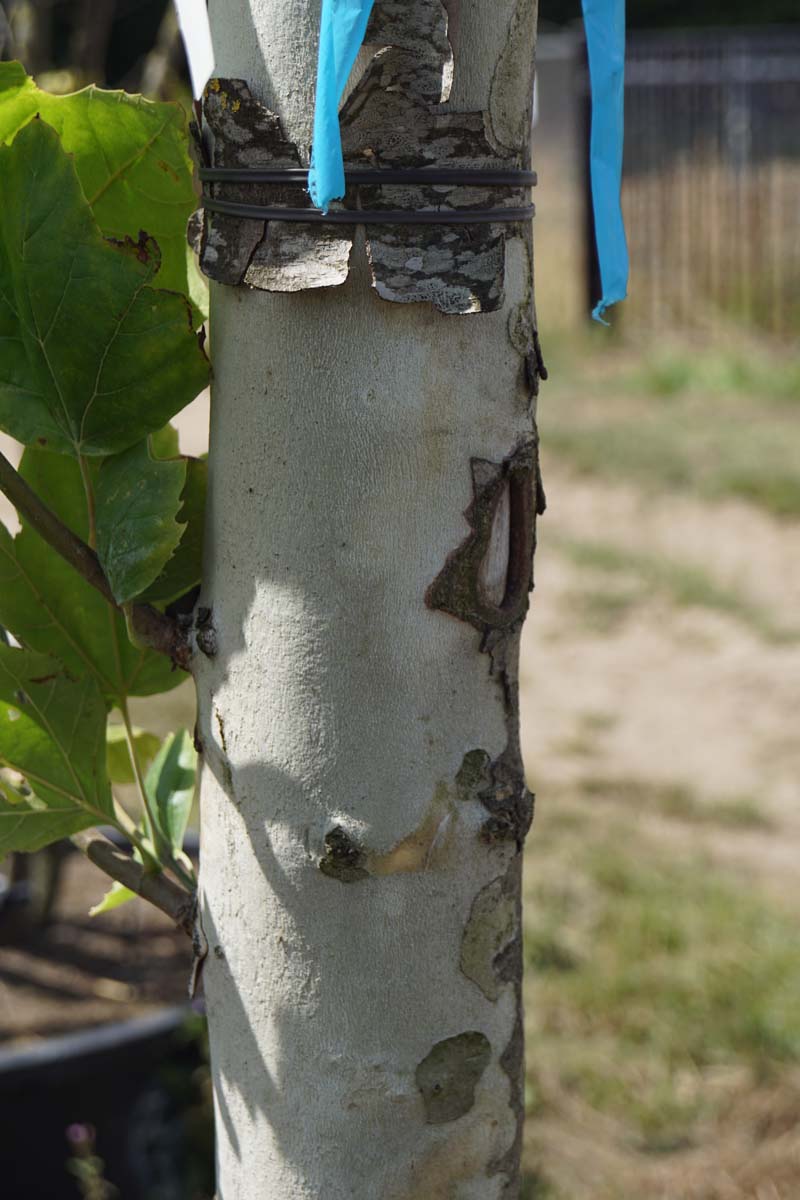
(95, 438), (186, 604)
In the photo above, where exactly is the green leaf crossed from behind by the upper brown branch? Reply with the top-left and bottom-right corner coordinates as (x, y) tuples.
(0, 449), (185, 704)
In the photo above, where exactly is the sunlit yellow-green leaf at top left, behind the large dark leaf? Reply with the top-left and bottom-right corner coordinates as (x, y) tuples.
(0, 62), (206, 311)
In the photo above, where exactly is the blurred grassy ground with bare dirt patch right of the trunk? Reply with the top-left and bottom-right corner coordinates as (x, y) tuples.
(522, 335), (800, 1200)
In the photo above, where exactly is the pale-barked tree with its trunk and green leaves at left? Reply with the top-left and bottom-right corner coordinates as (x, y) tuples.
(0, 0), (543, 1200)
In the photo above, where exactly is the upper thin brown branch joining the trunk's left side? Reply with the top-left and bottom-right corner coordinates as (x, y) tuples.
(0, 454), (191, 671)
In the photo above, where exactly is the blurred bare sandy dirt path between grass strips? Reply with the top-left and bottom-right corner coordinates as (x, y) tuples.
(521, 464), (800, 886)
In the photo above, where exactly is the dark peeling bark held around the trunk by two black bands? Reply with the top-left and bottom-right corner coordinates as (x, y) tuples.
(190, 0), (529, 313)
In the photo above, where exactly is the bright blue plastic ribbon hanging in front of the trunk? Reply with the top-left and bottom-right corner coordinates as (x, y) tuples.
(308, 0), (374, 212)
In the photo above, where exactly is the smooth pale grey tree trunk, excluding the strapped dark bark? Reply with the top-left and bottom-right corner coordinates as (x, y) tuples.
(197, 0), (537, 1200)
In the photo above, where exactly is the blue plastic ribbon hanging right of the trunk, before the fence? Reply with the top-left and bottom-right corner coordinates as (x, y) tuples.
(583, 0), (628, 324)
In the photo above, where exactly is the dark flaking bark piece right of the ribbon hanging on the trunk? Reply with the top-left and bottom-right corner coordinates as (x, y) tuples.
(341, 0), (525, 314)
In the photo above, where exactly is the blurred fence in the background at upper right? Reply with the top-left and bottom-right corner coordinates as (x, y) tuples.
(590, 28), (800, 337)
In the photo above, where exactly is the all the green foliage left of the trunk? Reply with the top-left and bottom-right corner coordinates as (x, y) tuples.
(0, 64), (207, 892)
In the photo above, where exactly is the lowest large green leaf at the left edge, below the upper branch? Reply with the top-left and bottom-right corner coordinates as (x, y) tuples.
(0, 643), (114, 854)
